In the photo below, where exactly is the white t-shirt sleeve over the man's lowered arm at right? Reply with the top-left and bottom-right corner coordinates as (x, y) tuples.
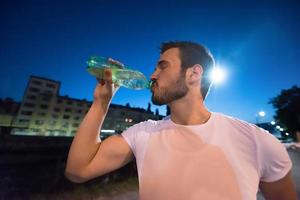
(257, 129), (292, 182)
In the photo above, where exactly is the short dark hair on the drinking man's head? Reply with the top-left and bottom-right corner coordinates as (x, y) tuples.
(160, 41), (215, 100)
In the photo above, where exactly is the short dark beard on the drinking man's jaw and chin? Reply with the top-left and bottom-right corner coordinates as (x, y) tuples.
(151, 72), (188, 106)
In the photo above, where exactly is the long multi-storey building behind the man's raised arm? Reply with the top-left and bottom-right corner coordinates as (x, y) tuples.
(6, 76), (163, 137)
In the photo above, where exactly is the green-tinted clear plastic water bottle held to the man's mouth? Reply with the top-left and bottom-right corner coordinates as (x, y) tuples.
(87, 56), (151, 90)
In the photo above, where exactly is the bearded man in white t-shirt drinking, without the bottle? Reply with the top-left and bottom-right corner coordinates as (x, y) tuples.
(66, 42), (296, 200)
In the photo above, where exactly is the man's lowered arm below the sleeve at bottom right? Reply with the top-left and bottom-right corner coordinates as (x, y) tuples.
(259, 172), (297, 200)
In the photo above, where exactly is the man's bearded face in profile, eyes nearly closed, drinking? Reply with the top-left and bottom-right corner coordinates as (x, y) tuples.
(151, 48), (188, 105)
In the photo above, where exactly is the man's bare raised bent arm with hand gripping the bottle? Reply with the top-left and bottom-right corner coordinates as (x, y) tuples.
(65, 70), (133, 182)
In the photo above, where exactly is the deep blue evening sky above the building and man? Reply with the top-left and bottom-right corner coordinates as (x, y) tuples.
(0, 0), (300, 122)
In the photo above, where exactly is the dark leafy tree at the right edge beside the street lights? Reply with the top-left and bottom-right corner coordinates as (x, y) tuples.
(269, 86), (300, 142)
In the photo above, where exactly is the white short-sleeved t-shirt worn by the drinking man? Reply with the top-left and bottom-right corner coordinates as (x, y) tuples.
(122, 113), (292, 200)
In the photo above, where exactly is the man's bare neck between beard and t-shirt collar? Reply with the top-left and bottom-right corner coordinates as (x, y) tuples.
(169, 96), (211, 125)
